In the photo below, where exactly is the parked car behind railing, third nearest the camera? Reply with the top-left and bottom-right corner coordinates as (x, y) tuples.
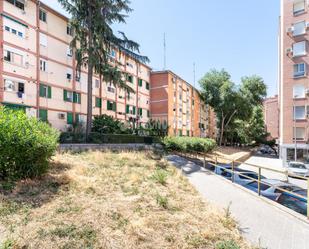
(222, 168), (266, 185)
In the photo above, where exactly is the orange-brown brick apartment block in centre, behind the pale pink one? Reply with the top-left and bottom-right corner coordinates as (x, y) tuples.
(150, 70), (210, 137)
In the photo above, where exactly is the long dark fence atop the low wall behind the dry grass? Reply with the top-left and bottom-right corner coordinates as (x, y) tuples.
(60, 132), (160, 144)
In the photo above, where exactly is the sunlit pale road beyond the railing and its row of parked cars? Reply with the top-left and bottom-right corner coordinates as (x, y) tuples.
(239, 155), (308, 189)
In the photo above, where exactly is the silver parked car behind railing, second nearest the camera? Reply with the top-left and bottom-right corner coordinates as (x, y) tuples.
(244, 179), (301, 200)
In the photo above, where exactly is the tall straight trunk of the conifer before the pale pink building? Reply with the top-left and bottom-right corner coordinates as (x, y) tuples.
(86, 4), (93, 142)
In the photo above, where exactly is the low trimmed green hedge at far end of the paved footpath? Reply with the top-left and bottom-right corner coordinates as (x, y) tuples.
(163, 137), (216, 153)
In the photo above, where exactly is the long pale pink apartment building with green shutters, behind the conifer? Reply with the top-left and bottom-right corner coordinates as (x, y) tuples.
(0, 0), (151, 131)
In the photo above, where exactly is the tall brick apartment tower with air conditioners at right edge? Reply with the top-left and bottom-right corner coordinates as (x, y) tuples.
(278, 0), (309, 164)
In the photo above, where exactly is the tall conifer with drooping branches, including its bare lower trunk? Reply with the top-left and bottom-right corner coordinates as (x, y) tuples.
(58, 0), (149, 139)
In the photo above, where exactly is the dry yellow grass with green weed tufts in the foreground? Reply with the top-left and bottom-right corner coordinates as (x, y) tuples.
(0, 152), (249, 249)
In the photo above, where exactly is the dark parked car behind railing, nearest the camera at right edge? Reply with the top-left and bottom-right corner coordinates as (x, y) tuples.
(277, 189), (307, 215)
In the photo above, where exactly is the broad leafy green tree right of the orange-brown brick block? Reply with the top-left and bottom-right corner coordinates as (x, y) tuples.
(199, 69), (266, 145)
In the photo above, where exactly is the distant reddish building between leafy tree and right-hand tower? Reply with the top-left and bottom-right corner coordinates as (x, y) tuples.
(263, 95), (279, 140)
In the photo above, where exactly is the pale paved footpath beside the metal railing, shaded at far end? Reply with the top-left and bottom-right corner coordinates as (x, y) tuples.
(166, 155), (309, 249)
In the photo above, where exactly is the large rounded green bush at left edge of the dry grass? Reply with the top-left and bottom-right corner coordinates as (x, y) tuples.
(0, 107), (59, 180)
